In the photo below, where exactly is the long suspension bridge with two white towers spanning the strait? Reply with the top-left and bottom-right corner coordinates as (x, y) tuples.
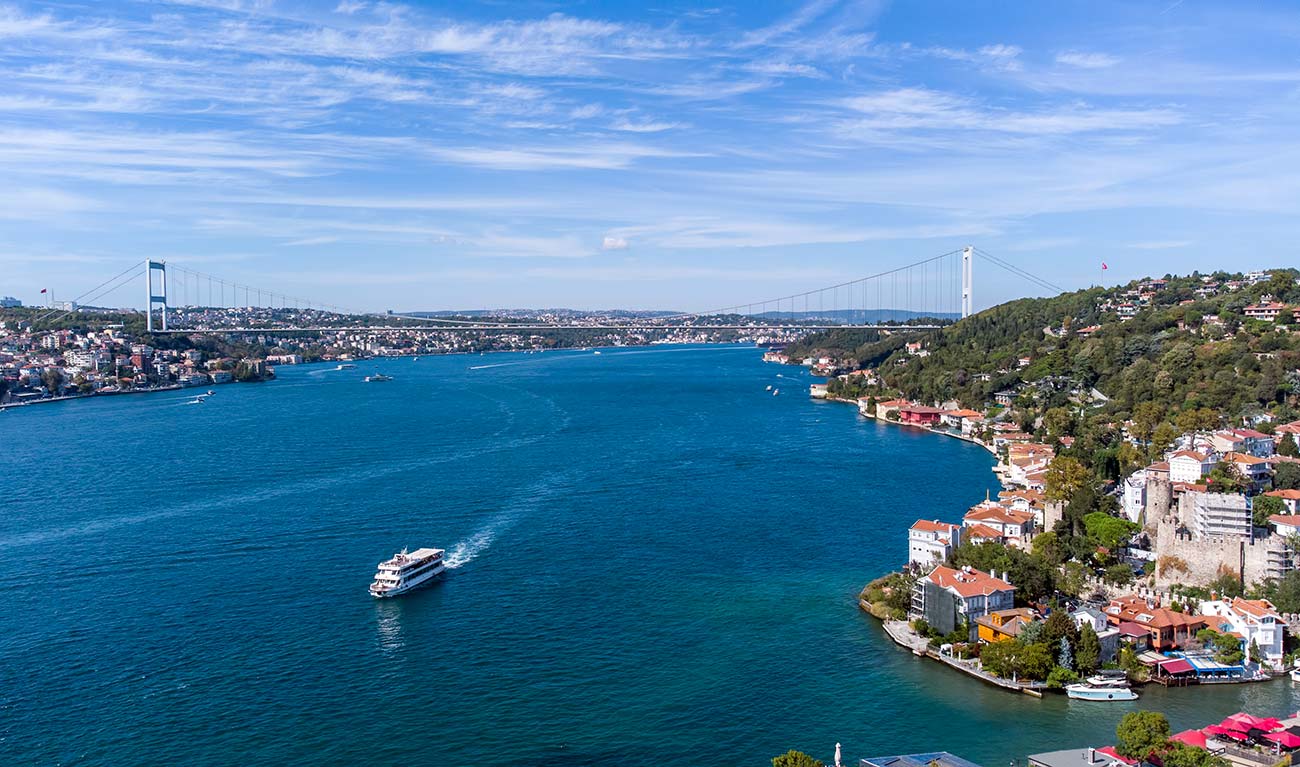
(39, 246), (1065, 334)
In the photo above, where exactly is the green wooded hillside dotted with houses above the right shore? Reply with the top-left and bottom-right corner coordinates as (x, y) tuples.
(792, 269), (1300, 478)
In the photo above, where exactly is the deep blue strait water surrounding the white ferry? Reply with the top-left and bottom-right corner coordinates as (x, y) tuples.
(0, 347), (1300, 767)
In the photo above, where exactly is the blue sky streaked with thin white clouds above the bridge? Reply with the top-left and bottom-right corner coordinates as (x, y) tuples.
(0, 0), (1300, 311)
